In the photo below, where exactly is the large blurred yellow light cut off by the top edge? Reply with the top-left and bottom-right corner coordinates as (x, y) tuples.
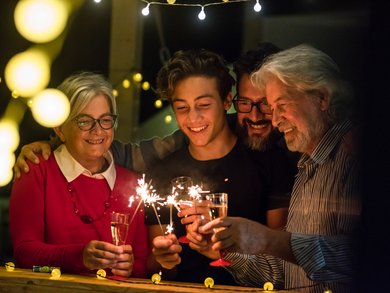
(14, 0), (69, 43)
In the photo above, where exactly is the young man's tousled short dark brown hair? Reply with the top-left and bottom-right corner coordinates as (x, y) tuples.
(156, 49), (235, 101)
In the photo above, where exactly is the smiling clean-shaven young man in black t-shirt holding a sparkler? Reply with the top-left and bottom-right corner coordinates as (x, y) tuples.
(147, 50), (284, 284)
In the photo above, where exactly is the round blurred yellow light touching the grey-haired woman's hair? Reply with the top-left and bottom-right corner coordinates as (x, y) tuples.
(31, 89), (70, 127)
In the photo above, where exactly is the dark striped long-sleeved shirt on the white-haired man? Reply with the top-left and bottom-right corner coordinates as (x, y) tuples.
(228, 121), (361, 293)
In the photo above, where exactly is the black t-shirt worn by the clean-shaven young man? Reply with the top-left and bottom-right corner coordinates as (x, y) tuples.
(145, 142), (291, 285)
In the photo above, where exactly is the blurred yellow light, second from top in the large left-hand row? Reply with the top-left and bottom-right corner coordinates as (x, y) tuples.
(5, 50), (50, 97)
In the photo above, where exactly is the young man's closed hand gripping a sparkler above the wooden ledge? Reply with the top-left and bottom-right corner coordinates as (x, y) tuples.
(152, 234), (182, 270)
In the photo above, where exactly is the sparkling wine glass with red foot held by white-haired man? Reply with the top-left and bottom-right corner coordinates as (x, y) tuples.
(206, 193), (232, 267)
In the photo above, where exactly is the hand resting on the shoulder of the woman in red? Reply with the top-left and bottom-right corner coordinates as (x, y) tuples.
(14, 141), (51, 179)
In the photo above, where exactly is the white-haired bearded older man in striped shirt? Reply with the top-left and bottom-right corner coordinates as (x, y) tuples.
(200, 45), (361, 293)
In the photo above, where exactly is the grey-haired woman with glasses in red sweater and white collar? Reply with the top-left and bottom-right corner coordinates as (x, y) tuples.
(9, 72), (149, 277)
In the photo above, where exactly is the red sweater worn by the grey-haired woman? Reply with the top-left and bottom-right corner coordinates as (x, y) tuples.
(9, 155), (149, 278)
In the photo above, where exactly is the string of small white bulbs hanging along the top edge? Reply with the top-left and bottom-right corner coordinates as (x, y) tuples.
(141, 0), (261, 20)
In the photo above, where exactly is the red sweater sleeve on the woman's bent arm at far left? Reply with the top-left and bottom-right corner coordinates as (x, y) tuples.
(9, 157), (86, 272)
